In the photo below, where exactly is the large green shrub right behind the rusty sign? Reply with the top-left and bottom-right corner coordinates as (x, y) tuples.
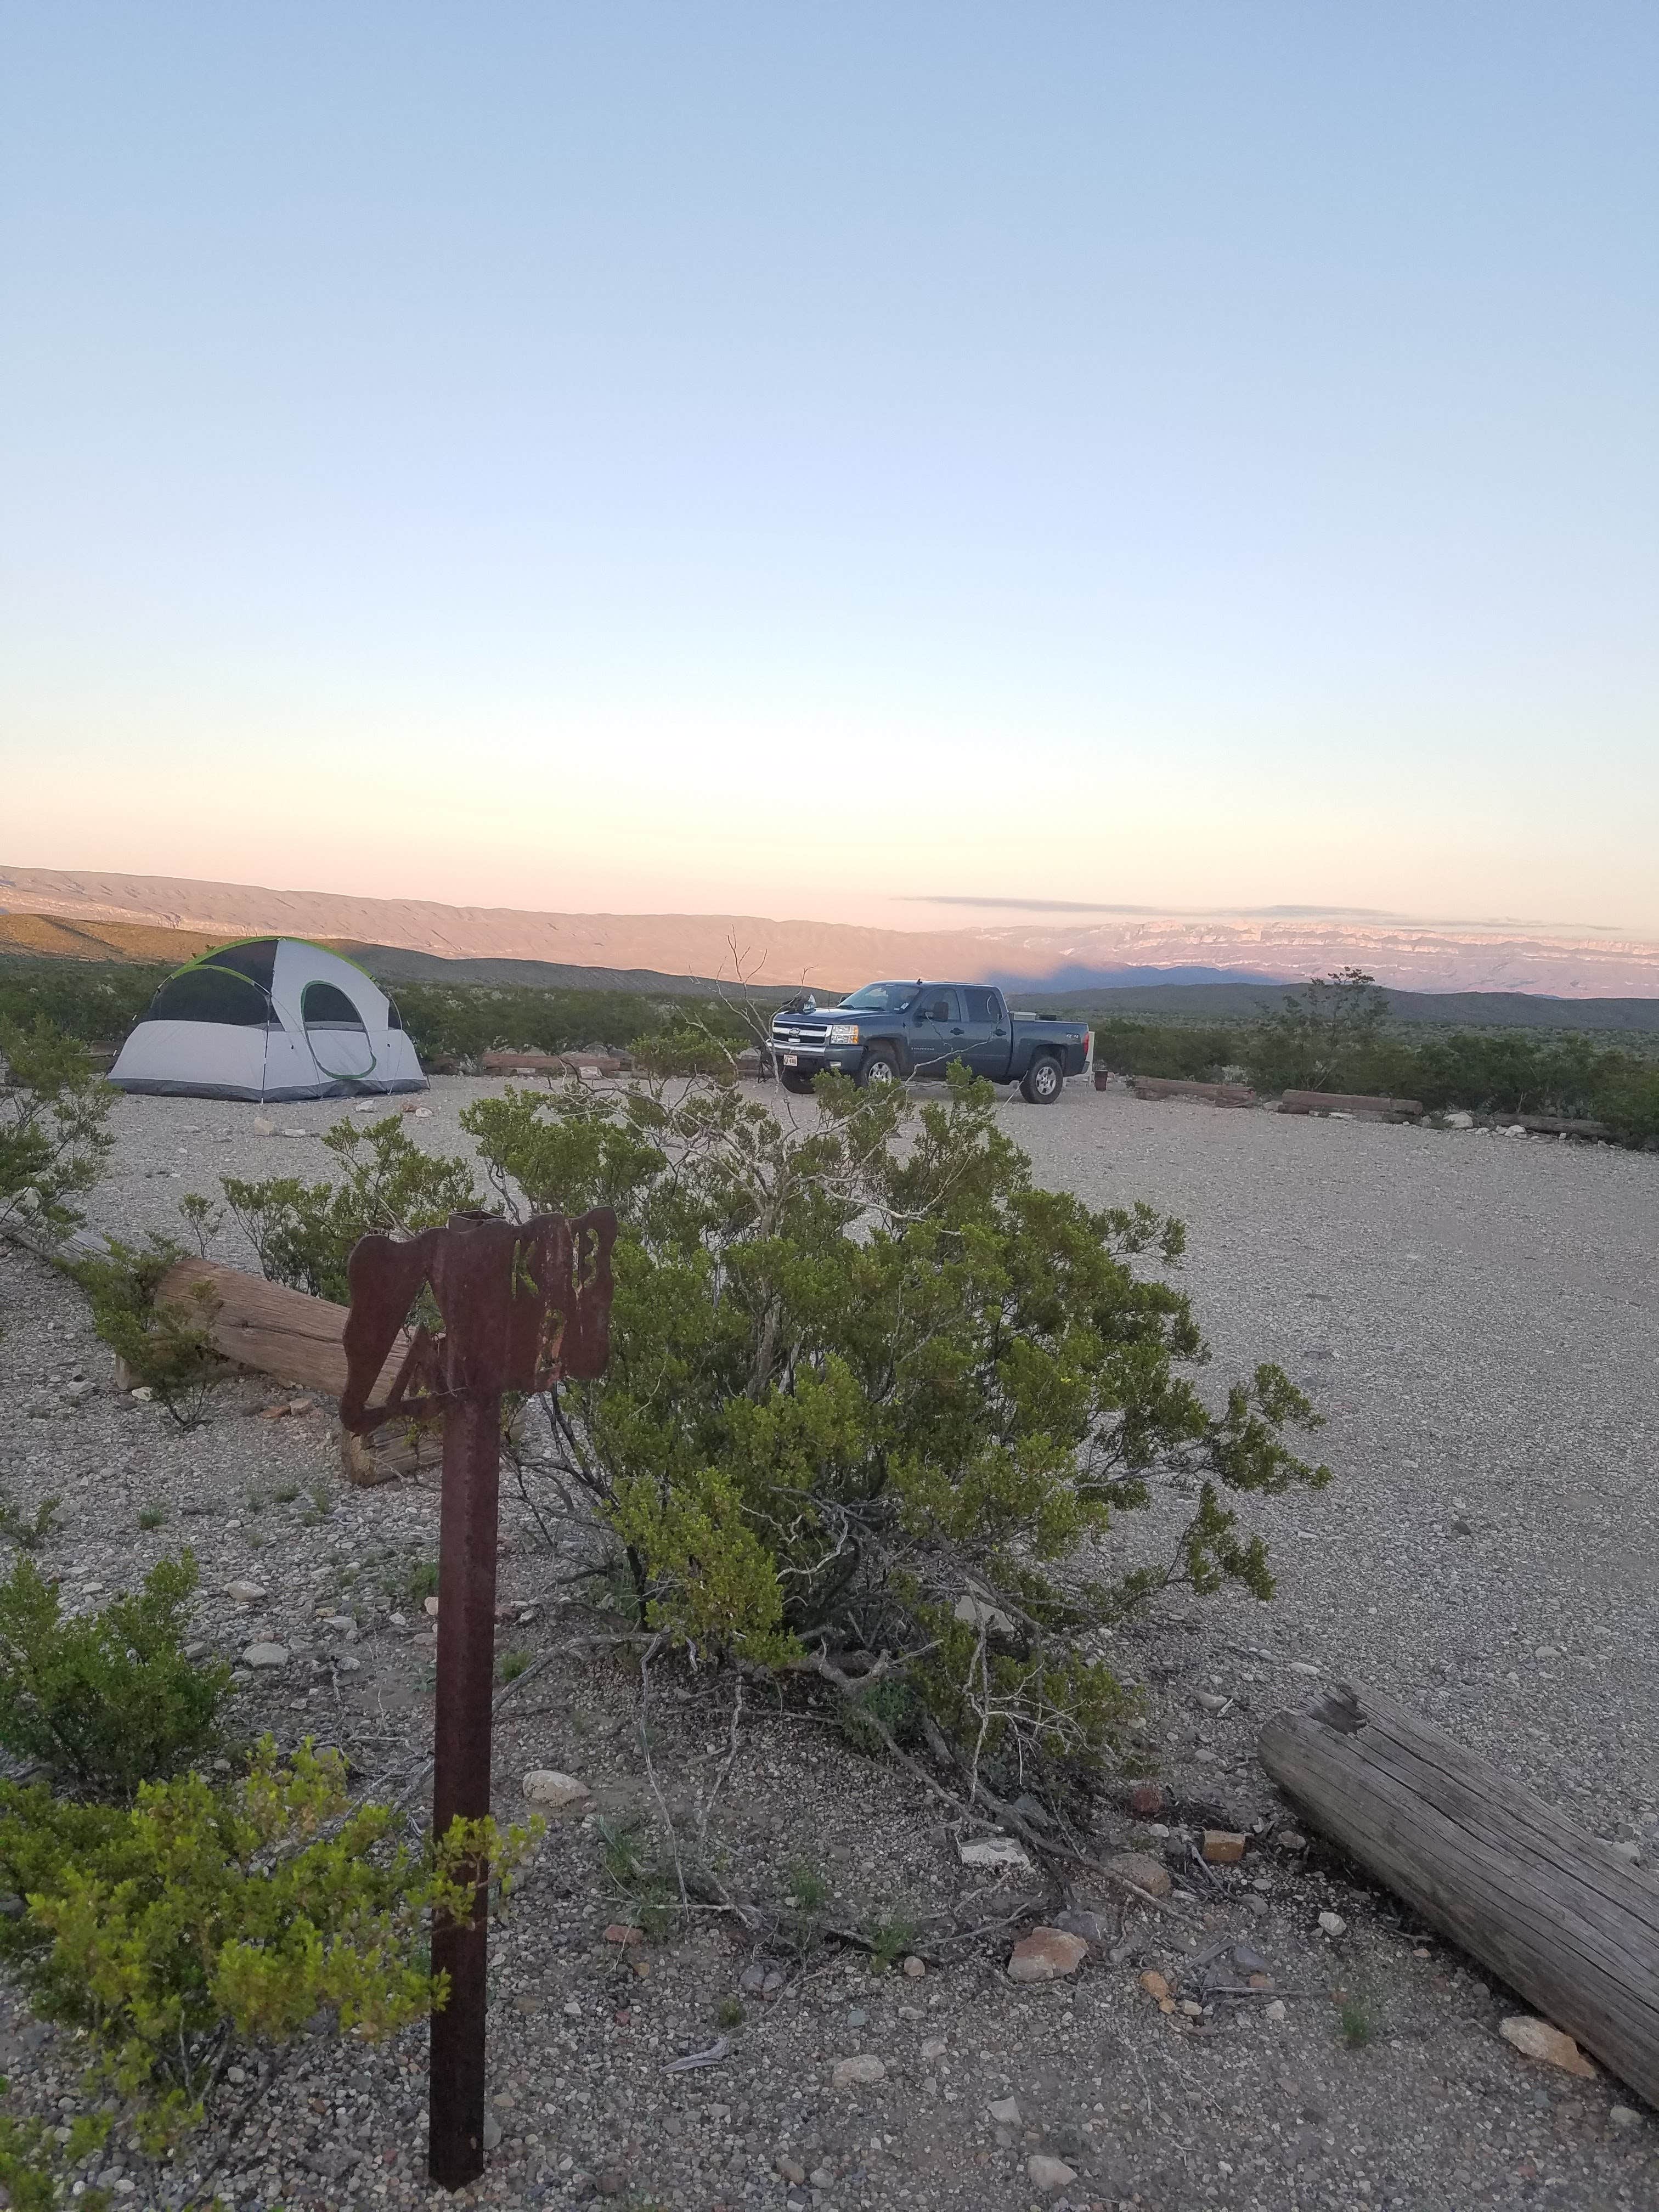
(462, 1073), (1327, 1814)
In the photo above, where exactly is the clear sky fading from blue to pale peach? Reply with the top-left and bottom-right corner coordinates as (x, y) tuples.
(0, 0), (1659, 936)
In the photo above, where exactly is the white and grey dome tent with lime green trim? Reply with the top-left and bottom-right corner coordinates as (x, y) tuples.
(109, 938), (427, 1099)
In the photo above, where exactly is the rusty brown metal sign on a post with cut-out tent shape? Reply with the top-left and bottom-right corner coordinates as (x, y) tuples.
(341, 1207), (617, 2190)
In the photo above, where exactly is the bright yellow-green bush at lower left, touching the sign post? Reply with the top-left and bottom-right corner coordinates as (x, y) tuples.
(0, 1741), (533, 2152)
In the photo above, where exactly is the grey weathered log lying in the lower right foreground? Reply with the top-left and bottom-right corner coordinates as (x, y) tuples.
(1261, 1683), (1659, 2103)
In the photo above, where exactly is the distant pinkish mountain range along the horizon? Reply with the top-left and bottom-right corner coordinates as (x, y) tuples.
(0, 867), (1659, 997)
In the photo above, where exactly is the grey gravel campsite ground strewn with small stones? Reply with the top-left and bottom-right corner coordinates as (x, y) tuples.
(0, 1080), (1659, 2212)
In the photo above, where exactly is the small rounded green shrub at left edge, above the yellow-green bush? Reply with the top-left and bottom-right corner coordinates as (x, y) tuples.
(0, 1550), (230, 1798)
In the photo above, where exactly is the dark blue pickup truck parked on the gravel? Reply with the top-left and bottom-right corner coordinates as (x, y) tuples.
(772, 982), (1091, 1106)
